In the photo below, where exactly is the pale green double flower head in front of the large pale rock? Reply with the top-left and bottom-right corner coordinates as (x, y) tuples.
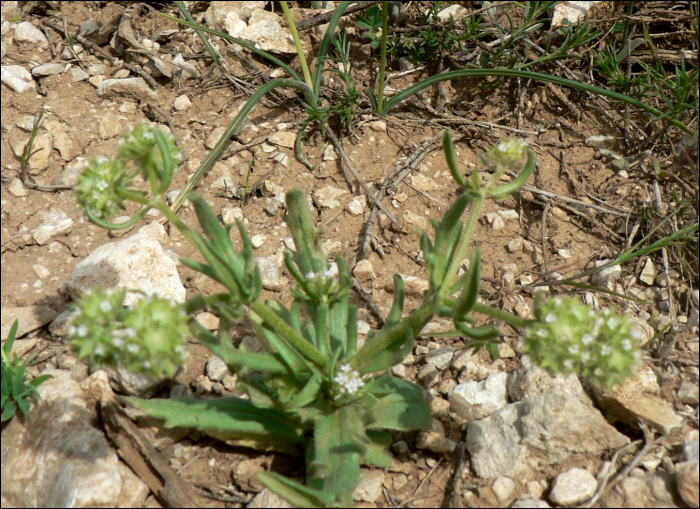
(69, 288), (189, 378)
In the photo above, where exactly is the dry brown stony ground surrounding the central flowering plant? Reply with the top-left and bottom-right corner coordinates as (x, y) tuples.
(0, 2), (698, 507)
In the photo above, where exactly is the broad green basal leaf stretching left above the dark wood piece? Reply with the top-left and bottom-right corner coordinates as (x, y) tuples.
(119, 397), (307, 452)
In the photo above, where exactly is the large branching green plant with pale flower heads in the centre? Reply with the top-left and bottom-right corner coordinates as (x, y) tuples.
(70, 122), (637, 507)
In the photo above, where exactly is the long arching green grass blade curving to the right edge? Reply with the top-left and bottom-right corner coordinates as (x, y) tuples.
(379, 69), (694, 134)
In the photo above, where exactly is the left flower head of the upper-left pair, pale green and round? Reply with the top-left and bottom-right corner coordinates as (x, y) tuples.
(75, 156), (133, 221)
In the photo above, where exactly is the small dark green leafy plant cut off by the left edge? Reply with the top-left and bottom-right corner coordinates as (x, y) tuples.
(0, 320), (51, 422)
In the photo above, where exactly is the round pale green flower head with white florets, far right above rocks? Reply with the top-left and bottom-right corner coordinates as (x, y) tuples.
(521, 297), (642, 388)
